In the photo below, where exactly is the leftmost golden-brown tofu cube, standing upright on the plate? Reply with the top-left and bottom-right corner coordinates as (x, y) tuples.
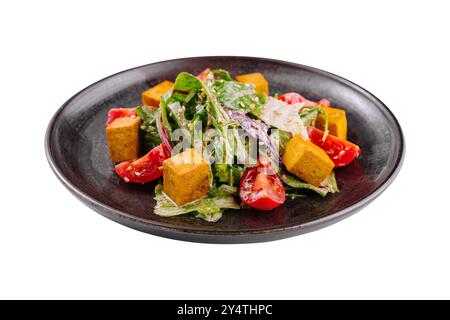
(106, 116), (141, 163)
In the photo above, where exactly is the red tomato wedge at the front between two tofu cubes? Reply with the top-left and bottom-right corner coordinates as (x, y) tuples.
(239, 158), (286, 210)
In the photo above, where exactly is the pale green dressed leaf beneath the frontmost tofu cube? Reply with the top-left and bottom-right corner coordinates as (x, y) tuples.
(155, 184), (240, 222)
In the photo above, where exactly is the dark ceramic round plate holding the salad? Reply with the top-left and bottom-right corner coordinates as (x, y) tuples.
(45, 57), (404, 243)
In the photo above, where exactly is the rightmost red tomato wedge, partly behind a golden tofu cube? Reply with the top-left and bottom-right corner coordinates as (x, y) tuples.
(307, 127), (361, 167)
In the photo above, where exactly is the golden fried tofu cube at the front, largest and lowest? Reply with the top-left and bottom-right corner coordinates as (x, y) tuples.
(163, 149), (210, 206)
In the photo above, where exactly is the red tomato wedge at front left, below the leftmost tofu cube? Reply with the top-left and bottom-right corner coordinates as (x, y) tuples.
(115, 144), (170, 183)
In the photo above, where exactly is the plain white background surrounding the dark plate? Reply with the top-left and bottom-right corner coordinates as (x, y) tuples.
(0, 0), (450, 299)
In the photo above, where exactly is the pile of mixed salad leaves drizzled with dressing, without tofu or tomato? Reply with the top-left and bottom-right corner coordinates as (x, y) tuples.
(137, 69), (339, 222)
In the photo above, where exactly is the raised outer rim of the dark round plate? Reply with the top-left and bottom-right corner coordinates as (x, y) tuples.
(45, 56), (405, 243)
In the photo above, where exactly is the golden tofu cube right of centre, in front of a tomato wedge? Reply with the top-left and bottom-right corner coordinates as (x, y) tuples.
(282, 135), (334, 187)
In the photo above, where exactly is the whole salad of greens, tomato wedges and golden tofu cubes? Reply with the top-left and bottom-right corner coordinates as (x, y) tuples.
(106, 68), (361, 222)
